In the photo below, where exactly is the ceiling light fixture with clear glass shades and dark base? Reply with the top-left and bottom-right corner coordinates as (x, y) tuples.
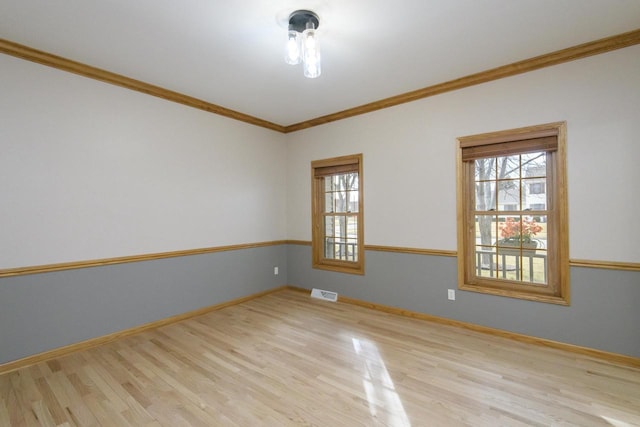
(285, 10), (322, 79)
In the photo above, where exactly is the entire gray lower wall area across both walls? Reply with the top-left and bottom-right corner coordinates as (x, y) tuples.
(0, 245), (640, 363)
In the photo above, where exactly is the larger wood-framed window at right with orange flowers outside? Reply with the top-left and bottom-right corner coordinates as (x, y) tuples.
(458, 123), (569, 305)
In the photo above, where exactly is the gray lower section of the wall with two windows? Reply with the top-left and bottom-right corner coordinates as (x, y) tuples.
(287, 245), (640, 357)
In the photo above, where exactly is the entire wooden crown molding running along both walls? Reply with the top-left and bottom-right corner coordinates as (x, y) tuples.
(0, 29), (640, 133)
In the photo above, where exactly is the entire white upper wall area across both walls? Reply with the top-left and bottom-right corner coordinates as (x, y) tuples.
(0, 46), (640, 269)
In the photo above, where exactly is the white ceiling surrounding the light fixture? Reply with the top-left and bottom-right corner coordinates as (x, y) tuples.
(0, 0), (640, 126)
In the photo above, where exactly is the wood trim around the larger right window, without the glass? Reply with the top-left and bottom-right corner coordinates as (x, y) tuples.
(456, 122), (570, 305)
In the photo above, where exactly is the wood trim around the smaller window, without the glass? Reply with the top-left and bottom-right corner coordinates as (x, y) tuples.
(311, 154), (364, 275)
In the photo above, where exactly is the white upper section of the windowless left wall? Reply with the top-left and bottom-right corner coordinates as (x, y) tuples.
(0, 55), (286, 269)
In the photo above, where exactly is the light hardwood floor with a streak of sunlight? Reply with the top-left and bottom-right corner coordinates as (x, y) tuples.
(0, 290), (640, 427)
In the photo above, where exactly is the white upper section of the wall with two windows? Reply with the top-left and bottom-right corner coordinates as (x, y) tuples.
(287, 46), (640, 262)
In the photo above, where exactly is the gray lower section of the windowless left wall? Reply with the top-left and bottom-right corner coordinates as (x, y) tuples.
(0, 245), (287, 363)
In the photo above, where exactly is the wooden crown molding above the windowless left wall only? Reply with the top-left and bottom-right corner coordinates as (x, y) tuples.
(0, 39), (284, 132)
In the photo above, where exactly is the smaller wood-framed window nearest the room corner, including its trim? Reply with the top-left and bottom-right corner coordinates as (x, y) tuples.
(311, 154), (364, 274)
